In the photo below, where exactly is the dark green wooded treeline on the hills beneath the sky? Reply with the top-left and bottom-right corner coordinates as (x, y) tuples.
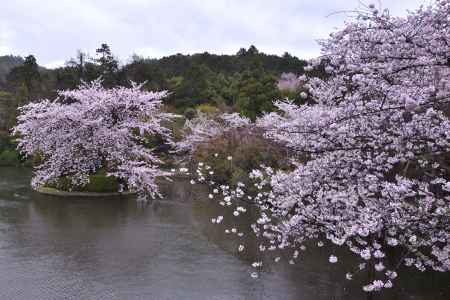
(0, 44), (322, 130)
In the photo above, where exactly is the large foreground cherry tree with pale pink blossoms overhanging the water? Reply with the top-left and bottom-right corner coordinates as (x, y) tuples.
(189, 0), (450, 292)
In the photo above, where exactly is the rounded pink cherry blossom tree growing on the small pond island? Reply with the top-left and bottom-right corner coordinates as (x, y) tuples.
(13, 80), (174, 197)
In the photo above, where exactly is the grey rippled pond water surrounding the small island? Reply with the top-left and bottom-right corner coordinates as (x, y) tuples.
(0, 168), (450, 300)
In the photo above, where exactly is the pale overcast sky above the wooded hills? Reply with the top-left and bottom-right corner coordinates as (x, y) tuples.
(0, 0), (431, 67)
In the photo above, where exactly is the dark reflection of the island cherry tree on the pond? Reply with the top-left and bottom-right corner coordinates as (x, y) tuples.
(0, 177), (197, 273)
